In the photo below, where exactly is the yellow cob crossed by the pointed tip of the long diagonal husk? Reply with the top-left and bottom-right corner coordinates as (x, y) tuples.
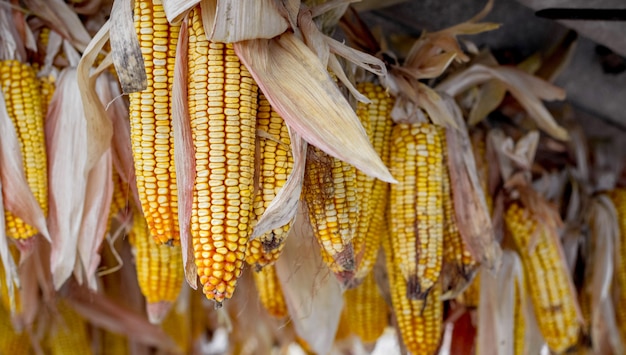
(354, 83), (394, 284)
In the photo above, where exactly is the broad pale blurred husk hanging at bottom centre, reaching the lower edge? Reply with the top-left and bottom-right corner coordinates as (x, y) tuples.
(275, 208), (343, 354)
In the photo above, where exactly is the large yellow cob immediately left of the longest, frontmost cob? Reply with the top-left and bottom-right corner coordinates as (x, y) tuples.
(129, 0), (180, 244)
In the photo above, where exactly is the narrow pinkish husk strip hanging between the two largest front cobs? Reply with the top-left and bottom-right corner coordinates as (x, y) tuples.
(169, 17), (198, 290)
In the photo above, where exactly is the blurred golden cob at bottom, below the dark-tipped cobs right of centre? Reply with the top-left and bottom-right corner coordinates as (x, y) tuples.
(344, 272), (388, 343)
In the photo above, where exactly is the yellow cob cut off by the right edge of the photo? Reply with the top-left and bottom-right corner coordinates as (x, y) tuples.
(609, 188), (626, 344)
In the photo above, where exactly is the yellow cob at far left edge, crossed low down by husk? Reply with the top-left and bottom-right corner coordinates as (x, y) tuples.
(0, 60), (48, 239)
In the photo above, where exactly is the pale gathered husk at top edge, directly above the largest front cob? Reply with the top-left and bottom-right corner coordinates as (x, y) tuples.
(200, 0), (289, 43)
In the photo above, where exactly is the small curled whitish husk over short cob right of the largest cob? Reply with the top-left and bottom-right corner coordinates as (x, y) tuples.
(250, 126), (307, 240)
